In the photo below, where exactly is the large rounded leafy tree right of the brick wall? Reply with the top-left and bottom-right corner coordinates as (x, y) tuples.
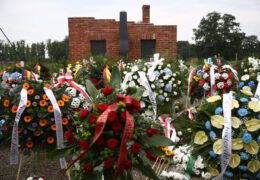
(193, 11), (245, 59)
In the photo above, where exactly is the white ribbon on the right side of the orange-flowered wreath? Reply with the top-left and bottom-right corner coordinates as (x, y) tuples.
(44, 87), (66, 169)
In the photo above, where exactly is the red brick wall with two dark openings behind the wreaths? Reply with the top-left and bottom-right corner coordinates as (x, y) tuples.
(68, 17), (177, 63)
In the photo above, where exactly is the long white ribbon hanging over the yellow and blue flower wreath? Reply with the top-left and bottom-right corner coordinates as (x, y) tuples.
(212, 92), (232, 180)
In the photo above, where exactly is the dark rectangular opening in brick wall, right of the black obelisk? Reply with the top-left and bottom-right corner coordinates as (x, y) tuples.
(141, 39), (156, 59)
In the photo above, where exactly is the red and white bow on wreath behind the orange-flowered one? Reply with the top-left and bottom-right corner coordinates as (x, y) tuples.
(54, 71), (92, 101)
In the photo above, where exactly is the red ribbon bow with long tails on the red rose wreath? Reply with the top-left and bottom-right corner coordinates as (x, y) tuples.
(64, 94), (140, 179)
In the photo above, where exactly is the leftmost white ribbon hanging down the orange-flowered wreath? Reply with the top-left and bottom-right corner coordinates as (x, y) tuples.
(10, 89), (27, 164)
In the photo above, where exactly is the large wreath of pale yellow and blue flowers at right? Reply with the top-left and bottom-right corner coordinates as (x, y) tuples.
(175, 90), (260, 179)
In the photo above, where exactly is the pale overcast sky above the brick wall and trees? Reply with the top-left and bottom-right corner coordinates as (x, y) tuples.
(0, 0), (260, 43)
